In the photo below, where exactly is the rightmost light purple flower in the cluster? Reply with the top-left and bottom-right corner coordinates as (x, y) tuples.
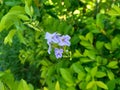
(59, 35), (71, 46)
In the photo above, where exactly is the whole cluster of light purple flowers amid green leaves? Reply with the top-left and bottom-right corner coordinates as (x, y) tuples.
(45, 32), (71, 59)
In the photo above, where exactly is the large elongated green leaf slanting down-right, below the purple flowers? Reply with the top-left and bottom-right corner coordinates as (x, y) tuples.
(60, 68), (74, 84)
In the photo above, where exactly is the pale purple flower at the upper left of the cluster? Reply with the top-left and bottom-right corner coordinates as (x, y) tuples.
(45, 32), (59, 45)
